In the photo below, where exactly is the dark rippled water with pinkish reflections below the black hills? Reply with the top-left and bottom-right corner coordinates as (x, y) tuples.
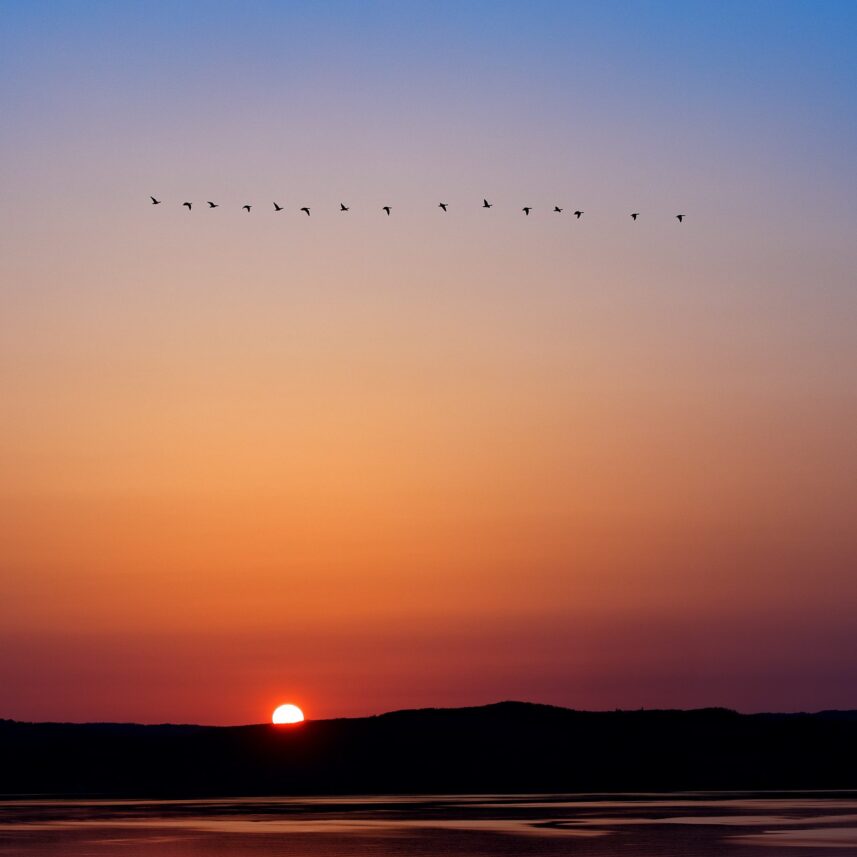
(0, 792), (857, 857)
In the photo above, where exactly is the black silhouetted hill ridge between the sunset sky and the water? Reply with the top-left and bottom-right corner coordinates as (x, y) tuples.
(0, 702), (857, 797)
